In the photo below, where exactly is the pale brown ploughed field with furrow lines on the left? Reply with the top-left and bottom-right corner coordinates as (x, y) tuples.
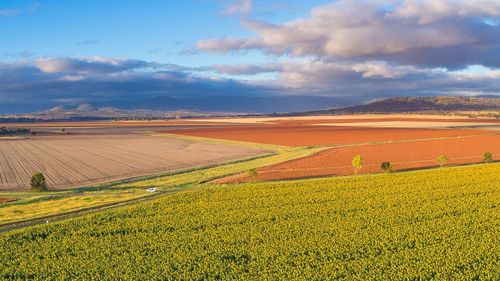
(0, 134), (264, 190)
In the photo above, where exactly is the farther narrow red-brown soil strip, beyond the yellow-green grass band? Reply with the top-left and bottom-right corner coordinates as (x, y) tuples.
(164, 125), (491, 146)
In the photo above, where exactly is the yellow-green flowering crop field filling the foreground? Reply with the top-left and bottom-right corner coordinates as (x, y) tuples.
(0, 164), (500, 280)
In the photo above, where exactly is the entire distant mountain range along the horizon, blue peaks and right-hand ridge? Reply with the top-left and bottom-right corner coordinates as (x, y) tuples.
(1, 96), (500, 119)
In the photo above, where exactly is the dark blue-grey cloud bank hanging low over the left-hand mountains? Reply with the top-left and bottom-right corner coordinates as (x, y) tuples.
(0, 57), (272, 111)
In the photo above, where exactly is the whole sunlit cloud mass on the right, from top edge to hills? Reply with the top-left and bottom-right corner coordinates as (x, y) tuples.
(196, 0), (500, 100)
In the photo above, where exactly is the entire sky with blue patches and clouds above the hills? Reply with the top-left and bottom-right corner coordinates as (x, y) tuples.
(0, 0), (500, 111)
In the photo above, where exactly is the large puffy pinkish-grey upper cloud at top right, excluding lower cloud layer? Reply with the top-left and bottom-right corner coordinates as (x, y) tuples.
(196, 0), (500, 68)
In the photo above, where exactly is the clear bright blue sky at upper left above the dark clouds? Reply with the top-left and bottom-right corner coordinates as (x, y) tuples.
(0, 0), (327, 66)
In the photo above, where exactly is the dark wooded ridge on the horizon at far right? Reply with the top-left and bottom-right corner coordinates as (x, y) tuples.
(297, 96), (500, 115)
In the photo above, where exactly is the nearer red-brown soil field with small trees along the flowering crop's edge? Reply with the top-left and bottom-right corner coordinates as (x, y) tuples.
(218, 135), (500, 183)
